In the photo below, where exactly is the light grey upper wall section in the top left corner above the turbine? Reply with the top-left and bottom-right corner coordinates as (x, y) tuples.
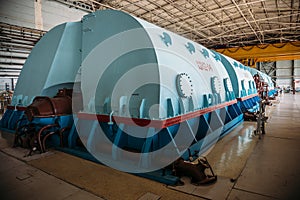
(0, 0), (87, 31)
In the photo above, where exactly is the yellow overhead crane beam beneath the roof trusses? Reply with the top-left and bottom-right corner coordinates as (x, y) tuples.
(215, 41), (300, 67)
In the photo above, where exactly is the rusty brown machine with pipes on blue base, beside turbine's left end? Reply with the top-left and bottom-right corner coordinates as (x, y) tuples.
(14, 89), (73, 155)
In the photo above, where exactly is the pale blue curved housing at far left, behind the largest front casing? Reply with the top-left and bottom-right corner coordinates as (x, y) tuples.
(0, 22), (81, 132)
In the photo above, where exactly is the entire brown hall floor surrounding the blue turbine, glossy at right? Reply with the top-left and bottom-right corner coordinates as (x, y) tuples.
(0, 94), (300, 200)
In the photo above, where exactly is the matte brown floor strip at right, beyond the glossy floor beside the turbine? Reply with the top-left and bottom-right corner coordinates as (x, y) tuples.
(229, 94), (300, 199)
